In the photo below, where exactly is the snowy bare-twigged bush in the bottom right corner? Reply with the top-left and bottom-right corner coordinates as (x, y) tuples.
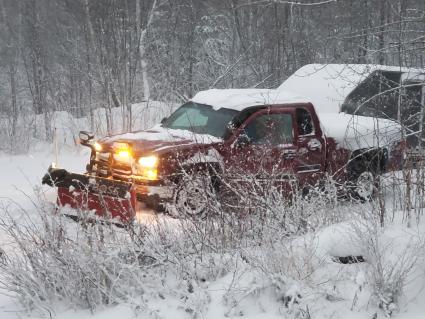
(352, 211), (424, 317)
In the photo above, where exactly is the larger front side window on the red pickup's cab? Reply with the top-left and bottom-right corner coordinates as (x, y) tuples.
(245, 113), (293, 145)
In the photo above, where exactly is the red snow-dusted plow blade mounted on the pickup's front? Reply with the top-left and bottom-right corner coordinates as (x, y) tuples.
(42, 168), (136, 224)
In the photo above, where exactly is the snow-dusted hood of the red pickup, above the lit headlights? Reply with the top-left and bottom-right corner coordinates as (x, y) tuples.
(99, 125), (223, 156)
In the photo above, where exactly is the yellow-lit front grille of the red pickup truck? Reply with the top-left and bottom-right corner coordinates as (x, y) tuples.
(94, 152), (132, 179)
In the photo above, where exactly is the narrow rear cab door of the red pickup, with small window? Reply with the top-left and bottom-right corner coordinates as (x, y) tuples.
(295, 107), (326, 185)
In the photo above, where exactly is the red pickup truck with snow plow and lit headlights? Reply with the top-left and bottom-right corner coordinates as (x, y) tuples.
(43, 89), (402, 221)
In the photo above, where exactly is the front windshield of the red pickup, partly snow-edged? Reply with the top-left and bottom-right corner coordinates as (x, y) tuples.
(162, 102), (239, 138)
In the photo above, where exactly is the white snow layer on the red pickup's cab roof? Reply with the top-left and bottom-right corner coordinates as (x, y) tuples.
(191, 89), (310, 111)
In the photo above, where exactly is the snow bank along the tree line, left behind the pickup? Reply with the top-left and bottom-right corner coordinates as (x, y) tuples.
(0, 101), (178, 153)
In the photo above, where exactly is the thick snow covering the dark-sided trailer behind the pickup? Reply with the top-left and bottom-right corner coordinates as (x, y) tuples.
(277, 64), (425, 113)
